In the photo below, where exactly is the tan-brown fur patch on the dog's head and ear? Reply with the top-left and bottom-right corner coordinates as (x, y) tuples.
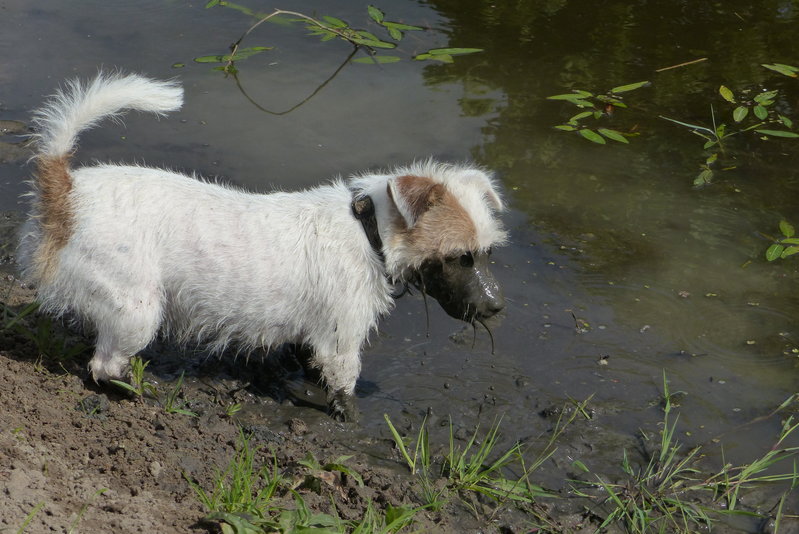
(390, 176), (478, 264)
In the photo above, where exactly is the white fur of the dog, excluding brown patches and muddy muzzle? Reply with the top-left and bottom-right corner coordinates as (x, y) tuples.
(19, 75), (504, 393)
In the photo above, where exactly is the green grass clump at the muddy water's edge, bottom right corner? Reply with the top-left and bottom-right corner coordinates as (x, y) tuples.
(574, 373), (799, 533)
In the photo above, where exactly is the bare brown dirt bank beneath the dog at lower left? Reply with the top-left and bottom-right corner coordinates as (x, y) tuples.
(0, 223), (579, 533)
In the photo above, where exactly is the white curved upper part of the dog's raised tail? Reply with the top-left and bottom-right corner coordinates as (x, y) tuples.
(34, 73), (183, 159)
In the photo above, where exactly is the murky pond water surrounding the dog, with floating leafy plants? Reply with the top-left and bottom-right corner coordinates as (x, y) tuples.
(0, 0), (799, 502)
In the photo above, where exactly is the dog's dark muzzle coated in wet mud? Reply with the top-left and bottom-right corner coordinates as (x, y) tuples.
(415, 252), (505, 323)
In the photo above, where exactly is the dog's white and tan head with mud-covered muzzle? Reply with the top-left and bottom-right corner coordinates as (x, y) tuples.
(372, 163), (506, 322)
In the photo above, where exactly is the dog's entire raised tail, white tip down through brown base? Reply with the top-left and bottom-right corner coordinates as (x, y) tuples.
(20, 73), (183, 281)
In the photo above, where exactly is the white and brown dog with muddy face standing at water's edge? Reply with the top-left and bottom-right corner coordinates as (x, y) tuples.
(18, 73), (507, 420)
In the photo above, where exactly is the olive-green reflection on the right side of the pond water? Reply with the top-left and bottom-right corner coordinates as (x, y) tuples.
(418, 0), (799, 390)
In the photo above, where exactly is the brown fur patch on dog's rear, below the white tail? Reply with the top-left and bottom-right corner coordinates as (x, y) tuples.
(34, 156), (74, 281)
